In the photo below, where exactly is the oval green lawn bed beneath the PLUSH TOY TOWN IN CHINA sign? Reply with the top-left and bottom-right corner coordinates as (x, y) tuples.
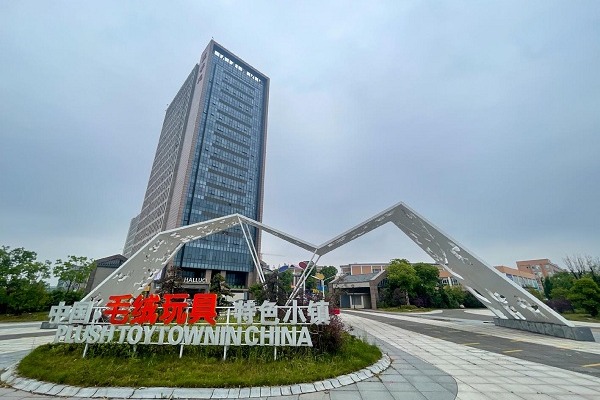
(18, 334), (381, 387)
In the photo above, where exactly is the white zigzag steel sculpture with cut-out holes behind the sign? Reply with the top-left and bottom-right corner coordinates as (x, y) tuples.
(83, 203), (594, 341)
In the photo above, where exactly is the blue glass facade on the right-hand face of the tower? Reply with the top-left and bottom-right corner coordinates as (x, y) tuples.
(175, 46), (268, 286)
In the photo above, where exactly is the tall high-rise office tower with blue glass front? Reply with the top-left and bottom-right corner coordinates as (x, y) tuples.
(125, 41), (269, 288)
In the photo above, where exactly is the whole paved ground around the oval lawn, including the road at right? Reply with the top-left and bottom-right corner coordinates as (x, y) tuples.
(0, 311), (600, 400)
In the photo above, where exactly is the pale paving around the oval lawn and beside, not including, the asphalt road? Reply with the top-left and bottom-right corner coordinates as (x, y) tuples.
(0, 312), (600, 400)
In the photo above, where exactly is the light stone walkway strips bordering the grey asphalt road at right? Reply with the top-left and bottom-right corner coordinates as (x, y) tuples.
(344, 312), (600, 400)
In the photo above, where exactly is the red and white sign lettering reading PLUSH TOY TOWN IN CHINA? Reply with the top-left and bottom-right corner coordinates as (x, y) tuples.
(49, 293), (330, 347)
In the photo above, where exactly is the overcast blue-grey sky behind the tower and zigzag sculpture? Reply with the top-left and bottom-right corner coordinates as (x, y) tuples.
(0, 0), (600, 274)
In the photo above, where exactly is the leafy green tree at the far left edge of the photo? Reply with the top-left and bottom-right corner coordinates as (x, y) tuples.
(0, 246), (51, 314)
